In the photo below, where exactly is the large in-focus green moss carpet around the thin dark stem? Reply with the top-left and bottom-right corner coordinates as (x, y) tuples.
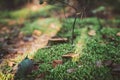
(30, 18), (120, 80)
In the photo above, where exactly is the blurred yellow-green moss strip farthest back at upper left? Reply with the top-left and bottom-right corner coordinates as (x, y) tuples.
(10, 5), (56, 19)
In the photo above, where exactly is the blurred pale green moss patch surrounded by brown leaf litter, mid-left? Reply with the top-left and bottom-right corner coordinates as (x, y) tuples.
(21, 18), (61, 34)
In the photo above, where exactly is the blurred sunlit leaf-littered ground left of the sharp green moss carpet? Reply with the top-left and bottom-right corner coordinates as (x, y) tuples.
(0, 5), (61, 80)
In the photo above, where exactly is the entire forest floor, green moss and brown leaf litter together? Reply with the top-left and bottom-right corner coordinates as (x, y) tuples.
(0, 5), (120, 80)
